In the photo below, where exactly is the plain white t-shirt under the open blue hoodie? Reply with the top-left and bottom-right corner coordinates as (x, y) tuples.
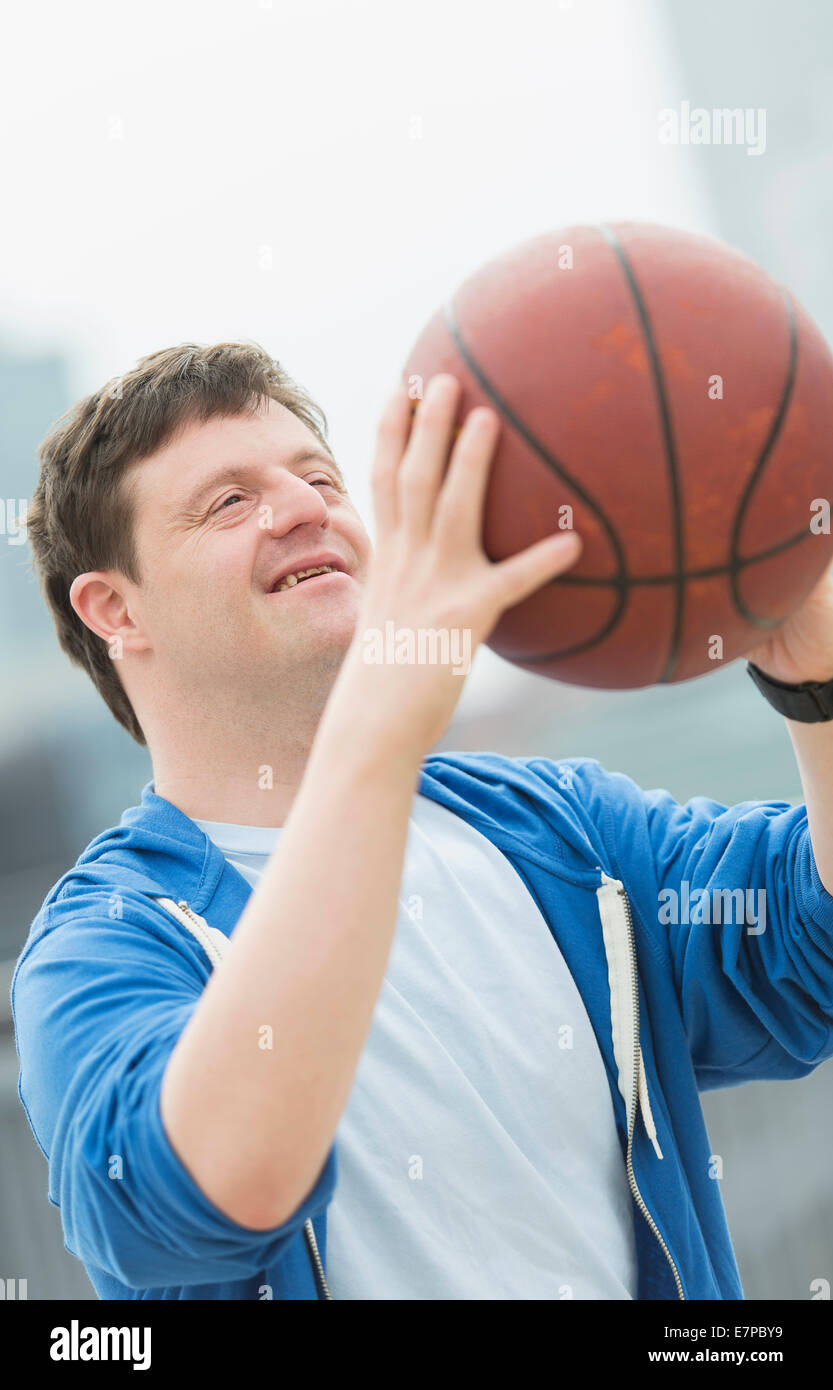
(196, 794), (637, 1300)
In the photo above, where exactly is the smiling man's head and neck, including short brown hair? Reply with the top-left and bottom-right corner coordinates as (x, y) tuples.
(52, 348), (370, 826)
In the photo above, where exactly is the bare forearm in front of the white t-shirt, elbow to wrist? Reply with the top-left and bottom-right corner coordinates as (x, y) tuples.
(161, 650), (421, 1229)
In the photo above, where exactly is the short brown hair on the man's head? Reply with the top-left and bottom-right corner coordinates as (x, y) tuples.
(26, 342), (331, 744)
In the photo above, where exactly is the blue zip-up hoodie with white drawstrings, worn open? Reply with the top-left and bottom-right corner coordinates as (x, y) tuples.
(11, 753), (833, 1300)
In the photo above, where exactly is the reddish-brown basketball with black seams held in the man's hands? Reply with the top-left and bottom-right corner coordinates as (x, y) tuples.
(403, 222), (833, 689)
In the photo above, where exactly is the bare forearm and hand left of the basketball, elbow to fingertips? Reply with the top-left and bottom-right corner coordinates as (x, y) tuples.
(160, 377), (580, 1229)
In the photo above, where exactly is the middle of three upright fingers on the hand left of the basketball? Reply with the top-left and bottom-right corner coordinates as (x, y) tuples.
(398, 373), (460, 539)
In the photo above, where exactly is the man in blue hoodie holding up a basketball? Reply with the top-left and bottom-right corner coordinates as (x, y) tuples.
(13, 343), (833, 1300)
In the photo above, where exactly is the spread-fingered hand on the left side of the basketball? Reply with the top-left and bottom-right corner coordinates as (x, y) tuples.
(331, 374), (581, 753)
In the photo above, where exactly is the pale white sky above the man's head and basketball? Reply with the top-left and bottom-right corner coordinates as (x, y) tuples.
(0, 0), (715, 702)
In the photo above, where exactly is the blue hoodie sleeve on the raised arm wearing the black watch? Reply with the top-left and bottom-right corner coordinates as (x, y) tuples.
(530, 750), (833, 1090)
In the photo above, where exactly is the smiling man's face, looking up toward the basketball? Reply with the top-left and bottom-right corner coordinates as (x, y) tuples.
(125, 400), (371, 706)
